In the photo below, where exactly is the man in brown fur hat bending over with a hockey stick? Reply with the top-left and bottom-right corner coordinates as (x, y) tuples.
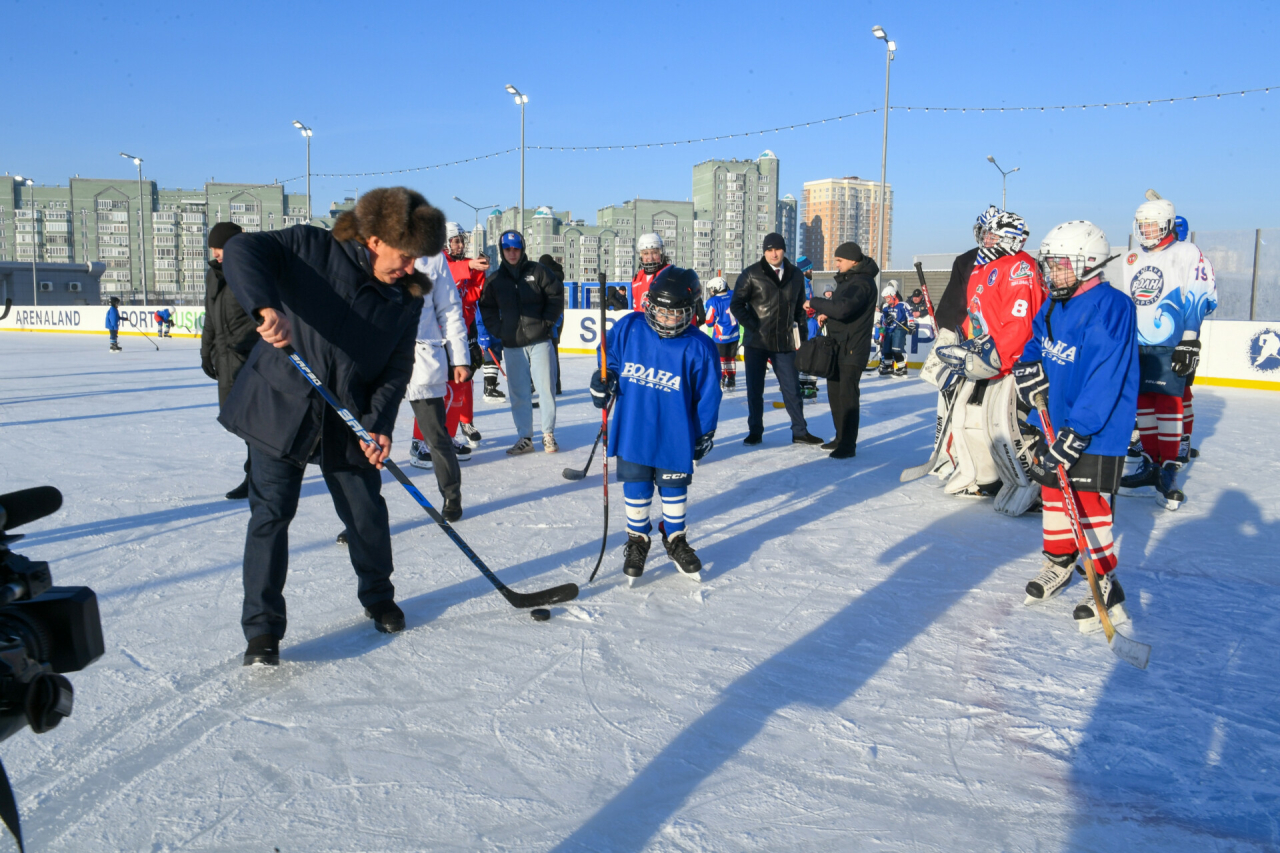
(218, 187), (444, 665)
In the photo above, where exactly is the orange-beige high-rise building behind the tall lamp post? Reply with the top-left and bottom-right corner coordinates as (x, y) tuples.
(803, 177), (893, 269)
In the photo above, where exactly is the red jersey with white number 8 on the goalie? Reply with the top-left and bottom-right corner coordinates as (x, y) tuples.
(965, 252), (1046, 377)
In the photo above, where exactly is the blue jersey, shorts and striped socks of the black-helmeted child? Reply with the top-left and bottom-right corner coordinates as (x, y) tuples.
(605, 311), (721, 537)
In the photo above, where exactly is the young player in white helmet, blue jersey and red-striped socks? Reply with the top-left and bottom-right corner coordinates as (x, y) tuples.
(1012, 220), (1139, 633)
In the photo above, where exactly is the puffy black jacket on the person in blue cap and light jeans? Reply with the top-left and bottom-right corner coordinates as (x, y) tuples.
(480, 235), (564, 347)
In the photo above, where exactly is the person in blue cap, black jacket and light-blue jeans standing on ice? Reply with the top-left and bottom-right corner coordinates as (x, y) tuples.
(480, 225), (564, 456)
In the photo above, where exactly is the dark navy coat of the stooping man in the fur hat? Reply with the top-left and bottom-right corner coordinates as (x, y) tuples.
(218, 222), (431, 467)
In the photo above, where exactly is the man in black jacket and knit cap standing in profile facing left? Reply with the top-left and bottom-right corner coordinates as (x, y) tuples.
(805, 243), (879, 459)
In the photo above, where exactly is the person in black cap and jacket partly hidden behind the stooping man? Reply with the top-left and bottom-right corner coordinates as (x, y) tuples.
(200, 222), (261, 501)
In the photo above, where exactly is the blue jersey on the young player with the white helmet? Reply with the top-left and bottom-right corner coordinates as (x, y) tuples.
(1020, 282), (1138, 456)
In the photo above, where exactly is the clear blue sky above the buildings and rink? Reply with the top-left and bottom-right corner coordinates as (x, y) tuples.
(0, 0), (1280, 265)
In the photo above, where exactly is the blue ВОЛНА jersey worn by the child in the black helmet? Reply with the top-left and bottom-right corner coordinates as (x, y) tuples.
(605, 313), (721, 474)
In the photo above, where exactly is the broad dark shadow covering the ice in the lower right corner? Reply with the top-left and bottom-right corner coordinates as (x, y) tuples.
(1066, 491), (1280, 850)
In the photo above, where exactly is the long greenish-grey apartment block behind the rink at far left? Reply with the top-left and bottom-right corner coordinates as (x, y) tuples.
(0, 177), (307, 301)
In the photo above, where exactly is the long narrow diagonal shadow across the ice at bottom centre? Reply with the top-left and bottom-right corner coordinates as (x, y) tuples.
(556, 499), (1039, 853)
